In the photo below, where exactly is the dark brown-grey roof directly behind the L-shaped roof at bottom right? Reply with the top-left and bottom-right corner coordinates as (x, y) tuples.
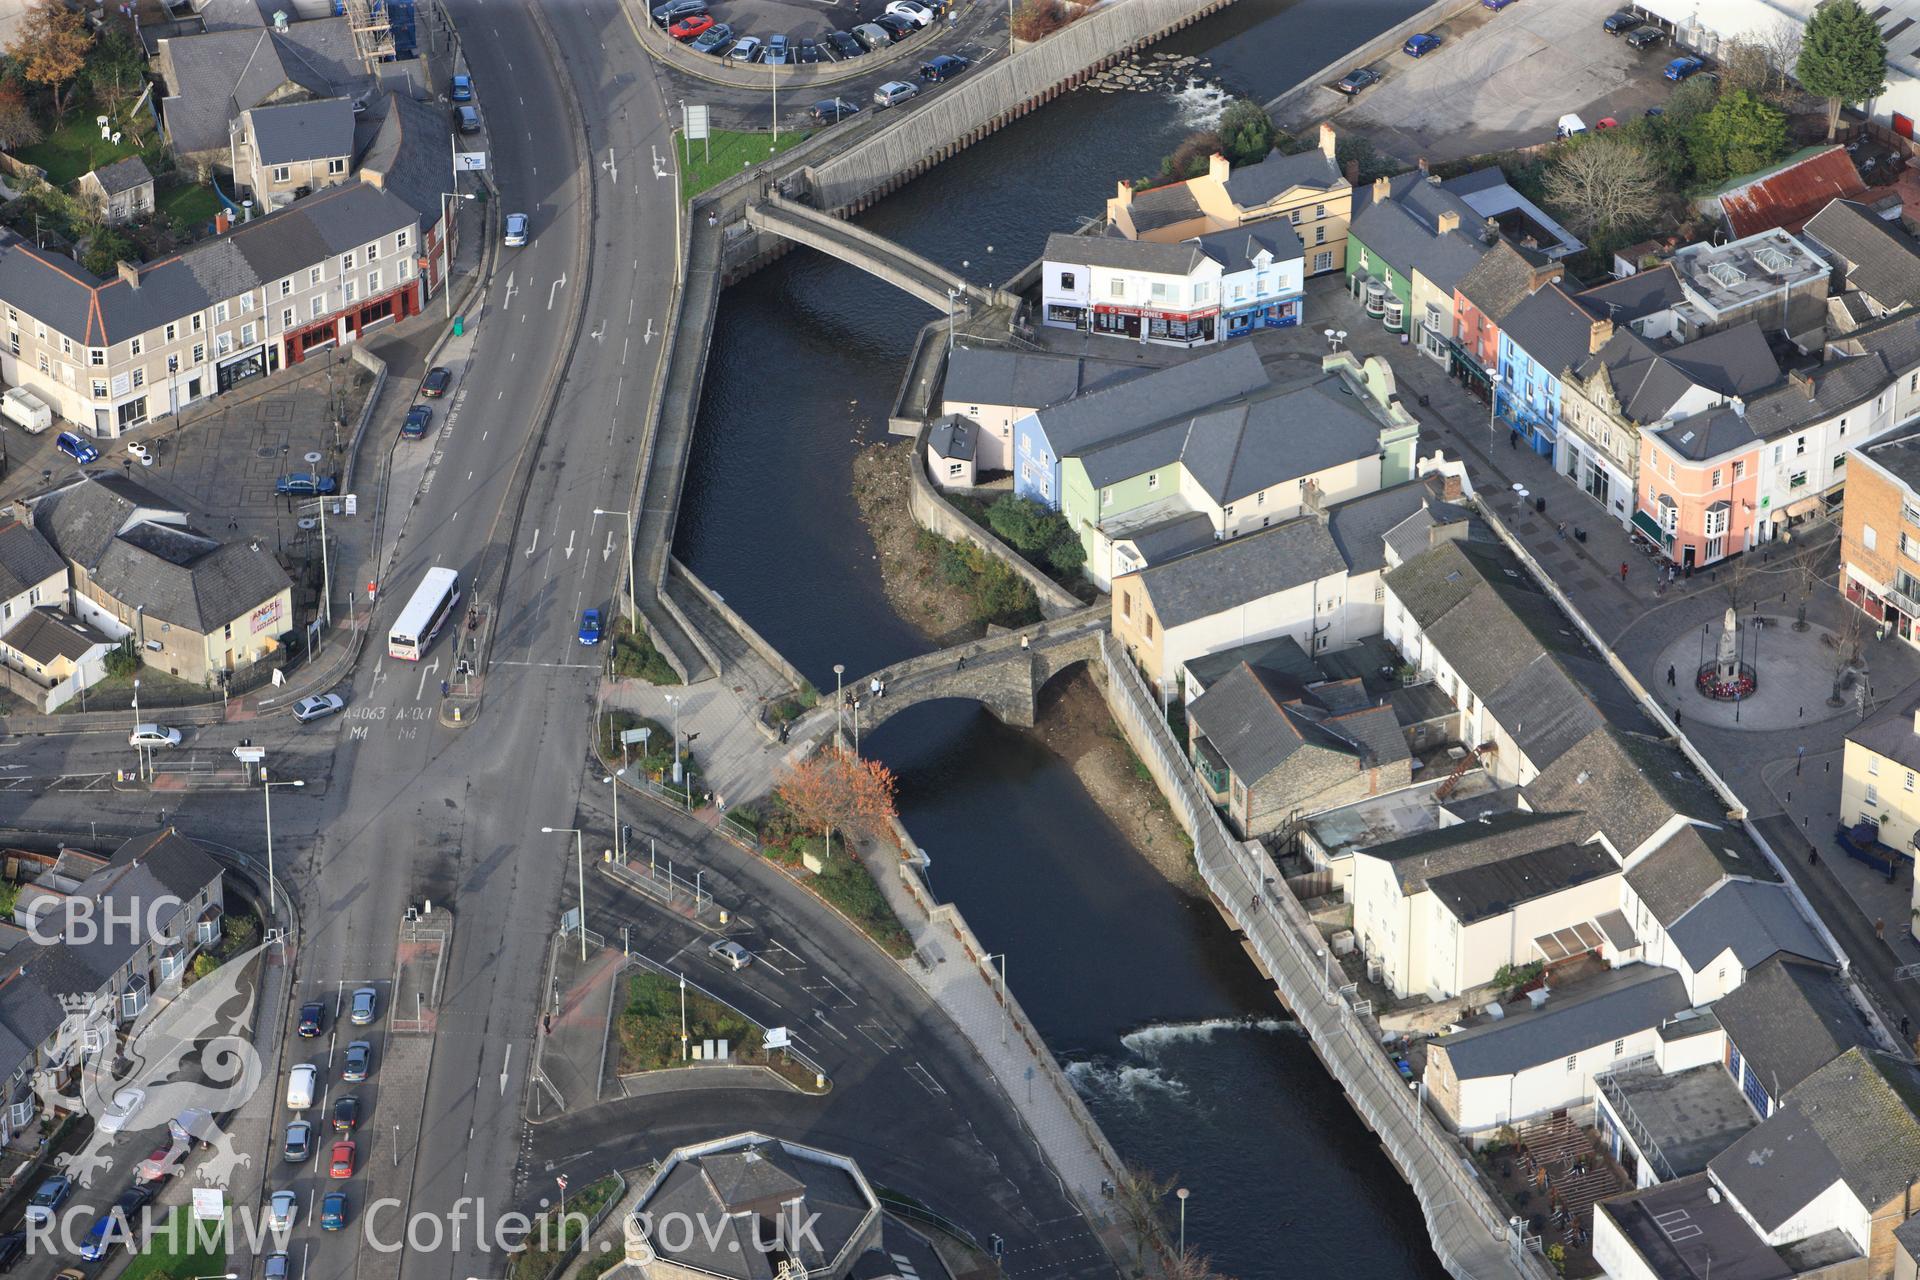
(1713, 955), (1874, 1100)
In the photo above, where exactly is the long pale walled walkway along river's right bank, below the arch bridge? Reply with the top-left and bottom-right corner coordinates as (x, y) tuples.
(1100, 633), (1551, 1280)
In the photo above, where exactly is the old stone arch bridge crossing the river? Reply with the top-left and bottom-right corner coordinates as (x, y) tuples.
(795, 603), (1110, 739)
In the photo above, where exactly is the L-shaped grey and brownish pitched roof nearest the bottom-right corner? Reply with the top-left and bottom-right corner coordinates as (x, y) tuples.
(1709, 1048), (1920, 1232)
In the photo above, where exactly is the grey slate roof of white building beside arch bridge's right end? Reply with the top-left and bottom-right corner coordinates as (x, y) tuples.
(1129, 516), (1346, 629)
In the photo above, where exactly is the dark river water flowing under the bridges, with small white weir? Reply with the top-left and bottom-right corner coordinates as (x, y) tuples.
(676, 0), (1444, 1280)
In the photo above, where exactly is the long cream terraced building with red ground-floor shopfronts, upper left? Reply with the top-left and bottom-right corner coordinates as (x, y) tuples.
(0, 182), (420, 438)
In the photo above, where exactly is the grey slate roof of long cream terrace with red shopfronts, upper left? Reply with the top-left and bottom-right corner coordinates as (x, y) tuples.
(0, 182), (419, 347)
